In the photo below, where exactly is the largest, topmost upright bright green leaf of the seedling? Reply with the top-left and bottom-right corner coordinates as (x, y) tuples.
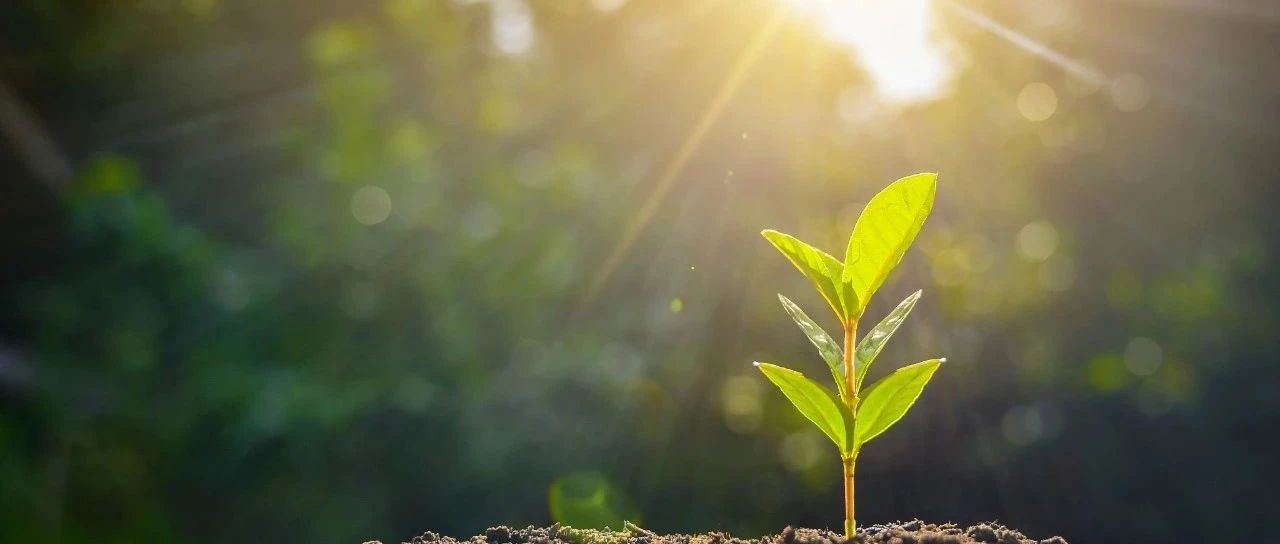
(840, 174), (938, 317)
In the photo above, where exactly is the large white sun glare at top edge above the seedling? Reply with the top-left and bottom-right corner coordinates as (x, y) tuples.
(787, 0), (952, 102)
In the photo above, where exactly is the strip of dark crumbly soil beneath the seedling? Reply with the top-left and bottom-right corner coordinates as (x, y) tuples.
(365, 520), (1066, 544)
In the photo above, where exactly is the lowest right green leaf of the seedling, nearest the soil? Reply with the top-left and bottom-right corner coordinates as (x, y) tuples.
(855, 358), (946, 448)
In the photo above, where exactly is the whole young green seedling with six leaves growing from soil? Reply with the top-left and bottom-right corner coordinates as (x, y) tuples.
(755, 174), (946, 538)
